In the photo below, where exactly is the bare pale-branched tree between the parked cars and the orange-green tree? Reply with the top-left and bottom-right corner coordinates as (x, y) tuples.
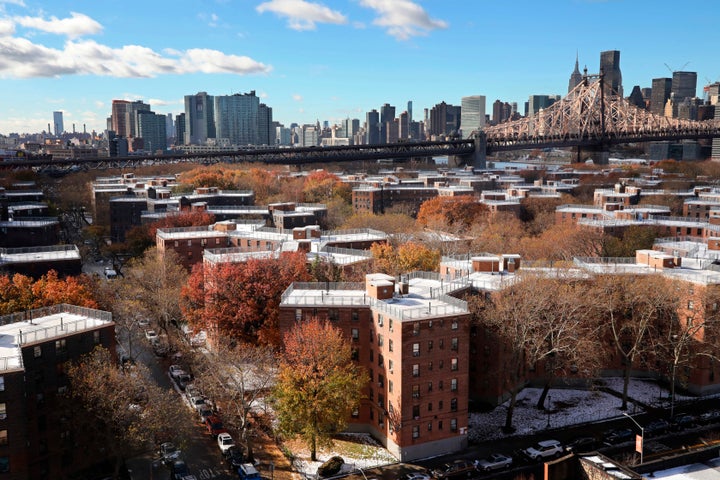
(188, 340), (277, 461)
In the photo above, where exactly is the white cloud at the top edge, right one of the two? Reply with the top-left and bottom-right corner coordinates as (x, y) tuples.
(360, 0), (448, 40)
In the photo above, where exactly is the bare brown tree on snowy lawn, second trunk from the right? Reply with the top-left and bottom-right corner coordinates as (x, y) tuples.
(588, 274), (681, 410)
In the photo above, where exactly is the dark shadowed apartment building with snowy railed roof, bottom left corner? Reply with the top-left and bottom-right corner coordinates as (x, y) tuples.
(0, 304), (115, 480)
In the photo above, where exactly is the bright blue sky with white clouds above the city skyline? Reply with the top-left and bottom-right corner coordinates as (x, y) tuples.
(0, 0), (720, 134)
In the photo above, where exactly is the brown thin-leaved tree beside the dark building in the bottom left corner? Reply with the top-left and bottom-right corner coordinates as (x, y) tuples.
(65, 347), (191, 478)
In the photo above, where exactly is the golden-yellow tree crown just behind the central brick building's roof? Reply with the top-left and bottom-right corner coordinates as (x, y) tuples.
(370, 242), (440, 276)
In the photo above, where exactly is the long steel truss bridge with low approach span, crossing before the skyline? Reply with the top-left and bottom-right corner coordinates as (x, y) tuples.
(5, 73), (720, 172)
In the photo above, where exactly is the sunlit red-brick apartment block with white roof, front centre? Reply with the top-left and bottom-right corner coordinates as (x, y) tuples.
(279, 273), (470, 461)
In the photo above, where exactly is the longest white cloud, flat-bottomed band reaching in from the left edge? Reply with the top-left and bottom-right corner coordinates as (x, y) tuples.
(0, 37), (272, 78)
